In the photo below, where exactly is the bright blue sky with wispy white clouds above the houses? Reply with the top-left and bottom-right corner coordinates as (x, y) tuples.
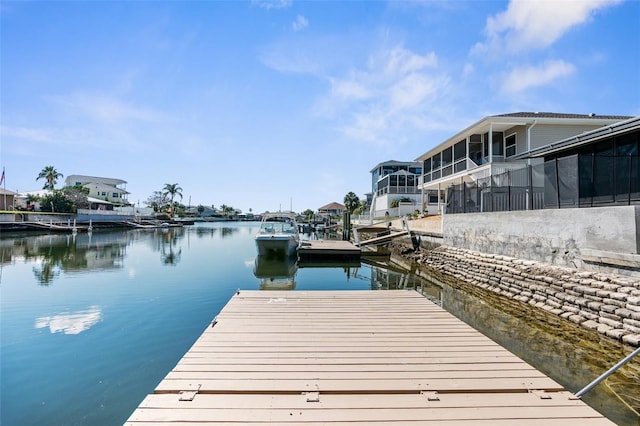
(0, 0), (640, 212)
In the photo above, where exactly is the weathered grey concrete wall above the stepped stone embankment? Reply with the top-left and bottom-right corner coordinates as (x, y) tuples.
(442, 206), (640, 268)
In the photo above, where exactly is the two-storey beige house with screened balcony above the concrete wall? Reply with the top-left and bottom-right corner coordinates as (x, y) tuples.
(416, 112), (632, 213)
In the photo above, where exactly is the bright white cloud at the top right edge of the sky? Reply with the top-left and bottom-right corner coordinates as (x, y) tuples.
(473, 0), (621, 53)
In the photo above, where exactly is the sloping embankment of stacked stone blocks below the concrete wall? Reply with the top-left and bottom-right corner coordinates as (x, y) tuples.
(402, 246), (640, 346)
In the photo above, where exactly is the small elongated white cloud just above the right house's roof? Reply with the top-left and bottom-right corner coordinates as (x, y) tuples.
(502, 60), (575, 93)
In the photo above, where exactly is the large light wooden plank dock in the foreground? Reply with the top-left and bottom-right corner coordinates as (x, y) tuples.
(126, 290), (613, 426)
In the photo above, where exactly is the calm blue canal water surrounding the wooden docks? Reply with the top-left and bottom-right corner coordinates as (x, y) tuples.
(0, 222), (637, 426)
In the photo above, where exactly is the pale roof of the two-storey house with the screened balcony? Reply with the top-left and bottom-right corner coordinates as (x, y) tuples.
(416, 112), (633, 161)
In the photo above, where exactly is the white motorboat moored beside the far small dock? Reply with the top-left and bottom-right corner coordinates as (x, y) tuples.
(256, 213), (300, 258)
